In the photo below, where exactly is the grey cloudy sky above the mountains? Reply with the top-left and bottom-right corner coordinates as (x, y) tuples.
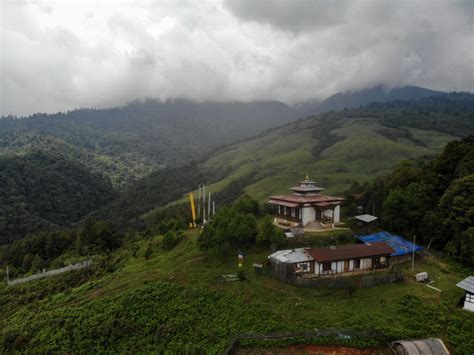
(0, 0), (474, 115)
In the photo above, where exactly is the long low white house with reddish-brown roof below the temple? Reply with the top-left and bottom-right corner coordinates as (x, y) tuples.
(268, 243), (394, 276)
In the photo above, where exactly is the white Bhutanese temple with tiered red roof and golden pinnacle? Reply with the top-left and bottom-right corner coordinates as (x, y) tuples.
(267, 175), (344, 229)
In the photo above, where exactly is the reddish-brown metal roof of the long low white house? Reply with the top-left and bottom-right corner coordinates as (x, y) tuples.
(307, 243), (394, 263)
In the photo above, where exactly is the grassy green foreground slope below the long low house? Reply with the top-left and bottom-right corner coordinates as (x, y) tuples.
(0, 232), (474, 352)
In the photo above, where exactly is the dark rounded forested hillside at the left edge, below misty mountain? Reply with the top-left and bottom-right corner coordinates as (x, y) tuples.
(0, 152), (115, 244)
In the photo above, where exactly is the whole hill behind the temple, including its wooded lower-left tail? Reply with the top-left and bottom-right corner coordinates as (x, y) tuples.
(112, 93), (474, 224)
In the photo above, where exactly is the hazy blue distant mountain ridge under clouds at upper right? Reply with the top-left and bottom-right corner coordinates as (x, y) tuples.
(295, 85), (443, 116)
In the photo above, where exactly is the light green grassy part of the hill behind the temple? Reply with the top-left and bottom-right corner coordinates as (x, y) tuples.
(193, 118), (455, 201)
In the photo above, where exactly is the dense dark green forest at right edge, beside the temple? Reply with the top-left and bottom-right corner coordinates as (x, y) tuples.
(346, 135), (474, 265)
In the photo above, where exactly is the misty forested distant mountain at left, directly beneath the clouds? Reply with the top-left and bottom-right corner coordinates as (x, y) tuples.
(0, 100), (296, 187)
